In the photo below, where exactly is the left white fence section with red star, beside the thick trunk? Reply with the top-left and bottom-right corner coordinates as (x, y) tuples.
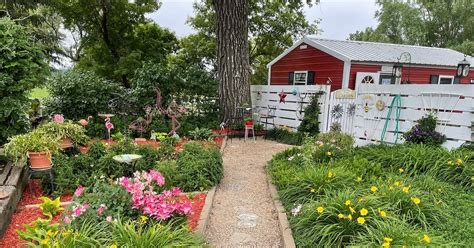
(251, 85), (331, 130)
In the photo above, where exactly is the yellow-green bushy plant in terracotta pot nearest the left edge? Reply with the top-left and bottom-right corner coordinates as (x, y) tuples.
(5, 129), (59, 169)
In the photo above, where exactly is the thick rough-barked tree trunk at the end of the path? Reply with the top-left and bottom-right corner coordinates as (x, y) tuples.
(213, 0), (250, 121)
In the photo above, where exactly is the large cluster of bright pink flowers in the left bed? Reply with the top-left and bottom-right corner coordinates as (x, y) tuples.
(118, 170), (191, 220)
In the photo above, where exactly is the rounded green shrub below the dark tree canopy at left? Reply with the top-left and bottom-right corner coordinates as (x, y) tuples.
(45, 70), (121, 120)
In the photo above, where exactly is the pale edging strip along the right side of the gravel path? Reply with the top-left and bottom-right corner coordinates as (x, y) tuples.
(267, 177), (296, 248)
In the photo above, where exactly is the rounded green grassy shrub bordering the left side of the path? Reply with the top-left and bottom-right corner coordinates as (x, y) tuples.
(177, 142), (224, 191)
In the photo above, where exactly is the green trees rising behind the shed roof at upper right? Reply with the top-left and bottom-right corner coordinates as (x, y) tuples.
(349, 0), (474, 55)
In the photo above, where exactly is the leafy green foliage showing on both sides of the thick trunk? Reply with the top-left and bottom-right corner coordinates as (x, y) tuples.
(188, 0), (319, 84)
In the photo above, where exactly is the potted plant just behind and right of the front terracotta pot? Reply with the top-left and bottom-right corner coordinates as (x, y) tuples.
(38, 120), (87, 149)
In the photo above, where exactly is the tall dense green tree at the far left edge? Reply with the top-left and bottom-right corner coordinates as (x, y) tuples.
(0, 18), (48, 144)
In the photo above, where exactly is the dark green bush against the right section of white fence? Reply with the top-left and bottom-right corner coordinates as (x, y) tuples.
(403, 114), (446, 146)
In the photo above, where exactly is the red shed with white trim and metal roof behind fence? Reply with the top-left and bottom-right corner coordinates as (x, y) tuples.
(267, 36), (474, 90)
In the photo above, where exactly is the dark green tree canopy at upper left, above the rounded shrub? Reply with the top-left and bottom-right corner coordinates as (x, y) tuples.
(50, 0), (177, 87)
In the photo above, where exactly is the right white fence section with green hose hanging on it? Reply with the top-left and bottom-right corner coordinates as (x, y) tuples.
(354, 84), (474, 149)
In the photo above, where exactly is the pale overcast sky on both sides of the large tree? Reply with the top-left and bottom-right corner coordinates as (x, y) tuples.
(148, 0), (377, 40)
